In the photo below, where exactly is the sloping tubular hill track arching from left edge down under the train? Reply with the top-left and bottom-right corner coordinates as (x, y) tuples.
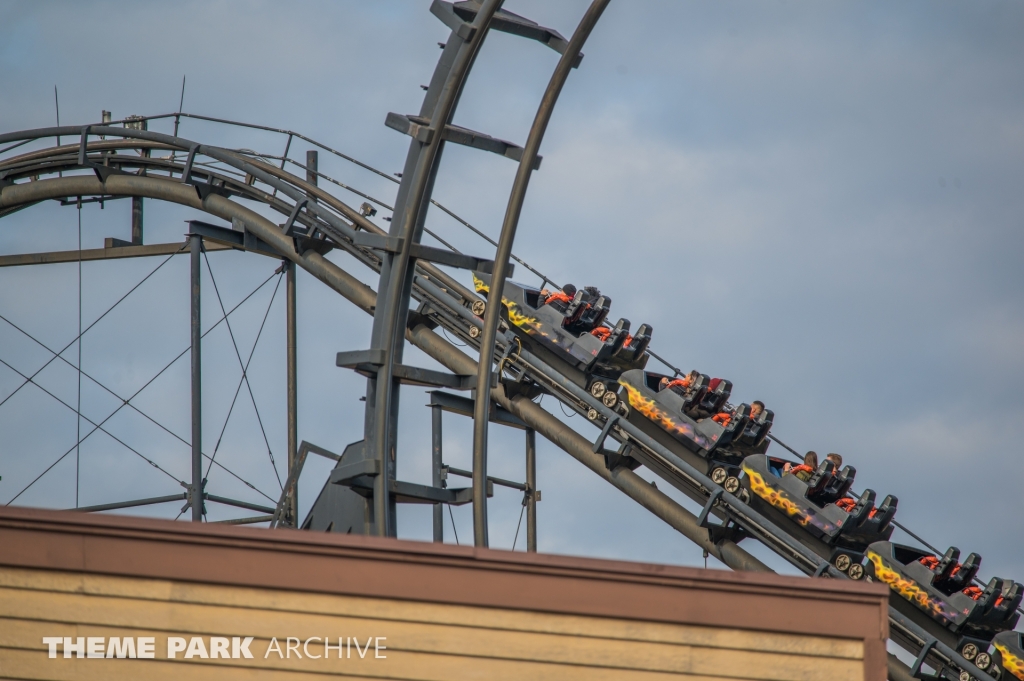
(0, 120), (985, 679)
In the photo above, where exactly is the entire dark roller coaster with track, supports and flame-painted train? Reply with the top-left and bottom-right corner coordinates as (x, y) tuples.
(0, 0), (1024, 681)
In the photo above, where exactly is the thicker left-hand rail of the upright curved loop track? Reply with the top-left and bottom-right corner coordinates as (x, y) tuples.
(365, 0), (503, 537)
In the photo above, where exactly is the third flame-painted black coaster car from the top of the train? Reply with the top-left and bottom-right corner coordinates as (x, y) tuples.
(741, 454), (898, 569)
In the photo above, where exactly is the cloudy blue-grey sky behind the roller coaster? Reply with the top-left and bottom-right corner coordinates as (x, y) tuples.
(0, 0), (1024, 593)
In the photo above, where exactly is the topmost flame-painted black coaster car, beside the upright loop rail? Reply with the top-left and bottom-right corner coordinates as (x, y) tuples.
(473, 272), (651, 399)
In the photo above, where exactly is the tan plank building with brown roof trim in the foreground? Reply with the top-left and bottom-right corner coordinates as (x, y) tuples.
(0, 509), (888, 681)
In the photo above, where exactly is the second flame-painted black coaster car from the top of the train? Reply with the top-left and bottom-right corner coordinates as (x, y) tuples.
(618, 369), (773, 485)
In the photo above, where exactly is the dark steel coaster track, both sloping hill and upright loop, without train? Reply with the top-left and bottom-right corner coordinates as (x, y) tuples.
(0, 5), (1011, 681)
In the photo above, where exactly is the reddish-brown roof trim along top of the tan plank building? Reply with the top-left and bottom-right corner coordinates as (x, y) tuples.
(0, 507), (888, 640)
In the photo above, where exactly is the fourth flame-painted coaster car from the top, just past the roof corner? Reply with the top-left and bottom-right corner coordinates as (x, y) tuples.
(865, 542), (1024, 655)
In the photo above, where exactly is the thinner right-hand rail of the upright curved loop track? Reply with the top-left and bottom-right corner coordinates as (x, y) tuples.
(473, 0), (610, 546)
